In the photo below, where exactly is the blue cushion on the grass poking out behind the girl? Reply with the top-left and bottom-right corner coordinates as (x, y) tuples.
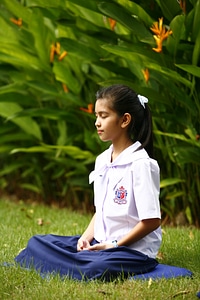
(130, 264), (192, 280)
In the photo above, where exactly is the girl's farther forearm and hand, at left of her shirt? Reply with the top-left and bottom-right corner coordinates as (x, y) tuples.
(77, 213), (96, 251)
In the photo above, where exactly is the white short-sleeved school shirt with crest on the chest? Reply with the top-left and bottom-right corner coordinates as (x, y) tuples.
(89, 142), (162, 258)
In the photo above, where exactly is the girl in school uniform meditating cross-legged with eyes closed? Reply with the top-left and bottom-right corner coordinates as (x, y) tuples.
(15, 85), (161, 280)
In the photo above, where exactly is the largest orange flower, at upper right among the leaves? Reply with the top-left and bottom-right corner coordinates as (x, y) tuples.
(150, 18), (172, 52)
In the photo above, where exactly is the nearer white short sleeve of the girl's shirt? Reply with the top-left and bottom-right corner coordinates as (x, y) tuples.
(132, 158), (161, 220)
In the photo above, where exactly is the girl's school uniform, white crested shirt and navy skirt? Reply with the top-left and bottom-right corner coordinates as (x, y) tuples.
(15, 142), (161, 280)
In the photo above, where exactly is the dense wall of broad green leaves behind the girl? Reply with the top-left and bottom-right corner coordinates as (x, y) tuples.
(0, 0), (200, 226)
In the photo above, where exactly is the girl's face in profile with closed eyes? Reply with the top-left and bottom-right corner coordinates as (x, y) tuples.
(95, 99), (124, 142)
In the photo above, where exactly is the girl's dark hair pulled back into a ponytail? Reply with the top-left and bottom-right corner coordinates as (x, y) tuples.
(96, 84), (153, 157)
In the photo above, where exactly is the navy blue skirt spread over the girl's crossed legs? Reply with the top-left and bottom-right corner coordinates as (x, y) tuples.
(15, 234), (158, 281)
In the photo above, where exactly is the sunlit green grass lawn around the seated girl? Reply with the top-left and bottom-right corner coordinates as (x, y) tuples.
(0, 199), (200, 300)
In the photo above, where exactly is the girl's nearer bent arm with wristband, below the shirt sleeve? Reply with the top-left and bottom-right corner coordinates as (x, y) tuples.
(88, 218), (161, 250)
